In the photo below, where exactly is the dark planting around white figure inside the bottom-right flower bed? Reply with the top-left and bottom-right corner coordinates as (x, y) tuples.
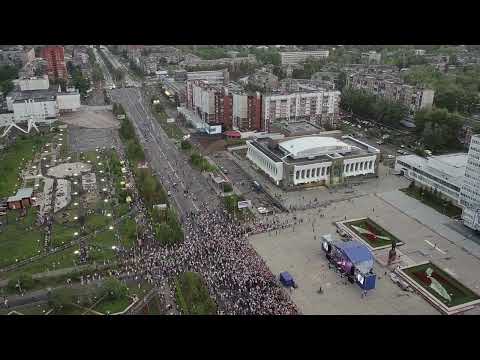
(403, 263), (480, 307)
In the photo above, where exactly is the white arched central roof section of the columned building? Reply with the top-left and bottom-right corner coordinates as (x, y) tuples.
(278, 136), (352, 159)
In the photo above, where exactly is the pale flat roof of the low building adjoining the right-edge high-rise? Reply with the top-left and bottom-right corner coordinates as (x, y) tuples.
(397, 153), (468, 187)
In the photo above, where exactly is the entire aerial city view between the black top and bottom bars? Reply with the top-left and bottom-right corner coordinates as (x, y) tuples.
(0, 45), (480, 316)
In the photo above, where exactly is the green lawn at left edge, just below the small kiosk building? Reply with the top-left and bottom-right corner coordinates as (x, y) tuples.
(0, 208), (43, 267)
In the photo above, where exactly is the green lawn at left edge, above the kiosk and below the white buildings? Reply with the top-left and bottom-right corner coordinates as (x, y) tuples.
(0, 135), (50, 198)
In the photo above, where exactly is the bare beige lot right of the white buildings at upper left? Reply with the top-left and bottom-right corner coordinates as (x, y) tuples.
(61, 109), (120, 129)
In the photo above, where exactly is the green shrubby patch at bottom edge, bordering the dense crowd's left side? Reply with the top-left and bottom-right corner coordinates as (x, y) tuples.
(175, 272), (217, 315)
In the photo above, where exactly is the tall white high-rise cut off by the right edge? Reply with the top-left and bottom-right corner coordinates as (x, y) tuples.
(460, 134), (480, 230)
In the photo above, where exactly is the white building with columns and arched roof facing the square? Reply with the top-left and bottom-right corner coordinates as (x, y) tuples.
(247, 135), (380, 188)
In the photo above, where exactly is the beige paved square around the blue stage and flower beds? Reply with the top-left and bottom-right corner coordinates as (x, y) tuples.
(250, 193), (480, 314)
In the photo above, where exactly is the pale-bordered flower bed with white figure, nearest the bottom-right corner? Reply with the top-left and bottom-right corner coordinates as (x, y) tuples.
(397, 261), (480, 315)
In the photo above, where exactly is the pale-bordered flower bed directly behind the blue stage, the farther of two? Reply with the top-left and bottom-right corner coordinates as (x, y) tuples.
(335, 218), (404, 251)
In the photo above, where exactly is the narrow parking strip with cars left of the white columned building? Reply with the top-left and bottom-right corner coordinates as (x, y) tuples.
(212, 151), (280, 212)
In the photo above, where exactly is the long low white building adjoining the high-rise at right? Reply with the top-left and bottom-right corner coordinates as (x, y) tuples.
(395, 153), (467, 204)
